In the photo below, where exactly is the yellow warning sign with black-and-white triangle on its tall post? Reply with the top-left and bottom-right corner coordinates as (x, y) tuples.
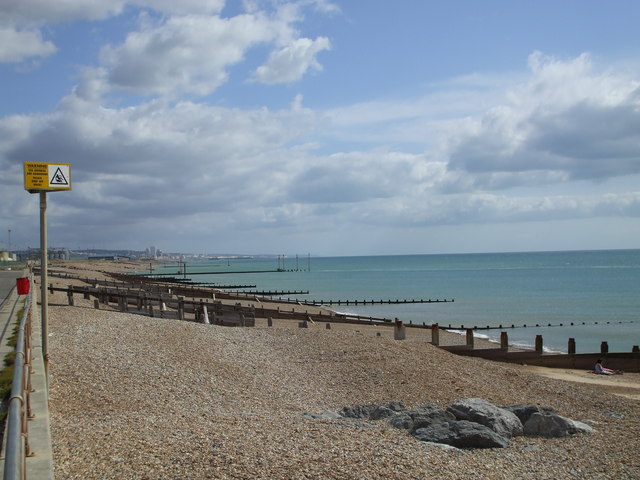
(23, 162), (71, 369)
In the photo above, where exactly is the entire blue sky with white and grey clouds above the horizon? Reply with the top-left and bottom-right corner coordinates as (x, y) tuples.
(0, 0), (640, 255)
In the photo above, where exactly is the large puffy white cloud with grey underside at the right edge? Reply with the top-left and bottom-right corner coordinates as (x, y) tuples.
(449, 53), (640, 179)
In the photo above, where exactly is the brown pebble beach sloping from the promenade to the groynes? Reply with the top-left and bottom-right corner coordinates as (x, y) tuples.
(42, 265), (640, 480)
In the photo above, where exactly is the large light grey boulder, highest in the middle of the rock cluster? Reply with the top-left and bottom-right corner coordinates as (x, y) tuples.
(447, 398), (522, 438)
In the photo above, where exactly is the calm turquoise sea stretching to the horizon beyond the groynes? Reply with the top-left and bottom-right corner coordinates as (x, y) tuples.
(154, 250), (640, 353)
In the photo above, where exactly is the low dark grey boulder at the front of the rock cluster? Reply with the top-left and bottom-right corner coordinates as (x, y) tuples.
(413, 420), (509, 448)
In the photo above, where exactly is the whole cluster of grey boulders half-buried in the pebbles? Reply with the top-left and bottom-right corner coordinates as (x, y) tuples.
(304, 398), (594, 448)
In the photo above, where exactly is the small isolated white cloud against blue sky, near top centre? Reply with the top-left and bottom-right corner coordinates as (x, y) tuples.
(254, 37), (331, 85)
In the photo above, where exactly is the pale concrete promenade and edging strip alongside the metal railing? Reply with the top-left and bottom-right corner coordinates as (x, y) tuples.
(0, 271), (54, 480)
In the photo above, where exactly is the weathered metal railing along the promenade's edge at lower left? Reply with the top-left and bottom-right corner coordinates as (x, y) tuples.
(3, 282), (32, 480)
